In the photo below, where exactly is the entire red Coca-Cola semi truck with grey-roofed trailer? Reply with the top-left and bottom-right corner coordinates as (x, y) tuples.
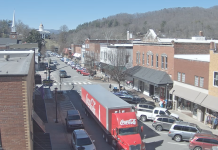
(81, 84), (145, 150)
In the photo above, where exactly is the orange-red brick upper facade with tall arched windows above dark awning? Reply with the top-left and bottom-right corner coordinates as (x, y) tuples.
(133, 44), (174, 79)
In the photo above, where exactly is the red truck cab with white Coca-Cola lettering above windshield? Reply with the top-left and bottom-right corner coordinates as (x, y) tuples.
(111, 112), (145, 150)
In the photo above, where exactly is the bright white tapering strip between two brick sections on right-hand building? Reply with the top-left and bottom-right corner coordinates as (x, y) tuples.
(174, 54), (210, 62)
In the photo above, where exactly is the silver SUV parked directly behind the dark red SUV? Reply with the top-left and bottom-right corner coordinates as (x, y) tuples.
(168, 122), (212, 142)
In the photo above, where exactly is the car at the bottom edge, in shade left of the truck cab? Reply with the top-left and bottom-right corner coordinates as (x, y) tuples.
(71, 129), (96, 150)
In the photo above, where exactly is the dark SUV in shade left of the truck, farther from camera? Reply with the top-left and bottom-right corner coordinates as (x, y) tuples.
(65, 110), (84, 132)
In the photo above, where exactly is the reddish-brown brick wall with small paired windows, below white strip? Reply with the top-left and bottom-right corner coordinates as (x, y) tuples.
(174, 58), (210, 89)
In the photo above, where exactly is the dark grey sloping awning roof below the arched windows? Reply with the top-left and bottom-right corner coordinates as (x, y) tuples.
(125, 66), (173, 85)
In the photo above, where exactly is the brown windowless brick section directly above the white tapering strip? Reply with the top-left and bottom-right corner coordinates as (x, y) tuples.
(174, 43), (210, 54)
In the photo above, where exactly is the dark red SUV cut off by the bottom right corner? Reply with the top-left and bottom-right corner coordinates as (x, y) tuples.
(189, 133), (218, 150)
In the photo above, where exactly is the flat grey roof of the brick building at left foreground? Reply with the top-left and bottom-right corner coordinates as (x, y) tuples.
(0, 50), (34, 76)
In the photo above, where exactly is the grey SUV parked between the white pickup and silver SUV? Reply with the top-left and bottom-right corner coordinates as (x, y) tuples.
(152, 115), (182, 131)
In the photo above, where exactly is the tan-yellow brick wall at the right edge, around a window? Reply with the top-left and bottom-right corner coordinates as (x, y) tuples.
(209, 50), (218, 97)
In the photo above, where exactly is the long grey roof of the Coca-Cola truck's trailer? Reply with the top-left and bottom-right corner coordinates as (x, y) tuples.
(82, 84), (132, 109)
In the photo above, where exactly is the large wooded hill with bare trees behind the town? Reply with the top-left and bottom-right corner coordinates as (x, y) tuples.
(68, 6), (218, 44)
